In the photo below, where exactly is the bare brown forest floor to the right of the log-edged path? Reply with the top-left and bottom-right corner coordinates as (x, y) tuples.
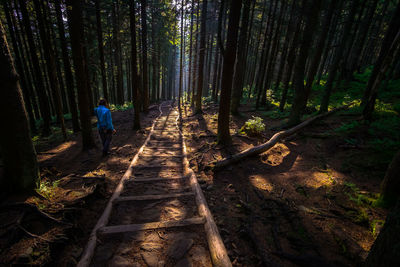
(184, 105), (386, 266)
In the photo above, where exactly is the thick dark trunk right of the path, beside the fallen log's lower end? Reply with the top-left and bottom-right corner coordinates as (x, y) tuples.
(218, 0), (242, 144)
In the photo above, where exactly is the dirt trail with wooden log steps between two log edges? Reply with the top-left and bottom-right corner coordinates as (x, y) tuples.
(78, 104), (229, 266)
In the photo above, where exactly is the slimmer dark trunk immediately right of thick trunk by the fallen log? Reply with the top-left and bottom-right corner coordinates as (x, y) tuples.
(230, 0), (250, 114)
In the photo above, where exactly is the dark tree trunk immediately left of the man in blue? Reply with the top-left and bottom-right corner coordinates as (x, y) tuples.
(66, 0), (95, 150)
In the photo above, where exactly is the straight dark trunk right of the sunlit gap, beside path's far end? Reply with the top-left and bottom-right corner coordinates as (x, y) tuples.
(195, 0), (208, 113)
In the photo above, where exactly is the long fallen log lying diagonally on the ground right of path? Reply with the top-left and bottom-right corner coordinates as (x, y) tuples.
(208, 104), (352, 170)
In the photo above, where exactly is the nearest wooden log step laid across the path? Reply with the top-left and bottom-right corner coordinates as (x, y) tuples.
(98, 217), (205, 235)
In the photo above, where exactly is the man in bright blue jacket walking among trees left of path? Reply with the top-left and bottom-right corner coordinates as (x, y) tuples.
(94, 98), (116, 156)
